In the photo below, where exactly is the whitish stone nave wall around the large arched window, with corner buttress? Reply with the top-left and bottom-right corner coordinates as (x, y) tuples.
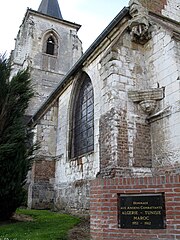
(35, 12), (179, 212)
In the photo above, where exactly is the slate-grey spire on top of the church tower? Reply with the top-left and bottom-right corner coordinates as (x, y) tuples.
(38, 0), (63, 19)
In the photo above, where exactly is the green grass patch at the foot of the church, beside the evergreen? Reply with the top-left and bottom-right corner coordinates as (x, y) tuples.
(0, 209), (80, 240)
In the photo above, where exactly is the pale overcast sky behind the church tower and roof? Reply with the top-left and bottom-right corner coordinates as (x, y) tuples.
(0, 0), (129, 53)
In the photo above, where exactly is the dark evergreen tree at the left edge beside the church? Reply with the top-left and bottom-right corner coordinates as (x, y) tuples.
(0, 56), (33, 220)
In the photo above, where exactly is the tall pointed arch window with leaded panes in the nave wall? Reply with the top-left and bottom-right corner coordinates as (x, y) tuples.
(71, 74), (94, 157)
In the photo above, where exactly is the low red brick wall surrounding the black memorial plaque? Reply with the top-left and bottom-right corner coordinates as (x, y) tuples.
(90, 174), (180, 240)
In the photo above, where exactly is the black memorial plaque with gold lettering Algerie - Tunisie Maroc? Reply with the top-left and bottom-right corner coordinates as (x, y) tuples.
(119, 194), (165, 229)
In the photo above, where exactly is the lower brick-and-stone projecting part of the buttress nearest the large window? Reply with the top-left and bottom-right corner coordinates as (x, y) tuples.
(99, 108), (128, 171)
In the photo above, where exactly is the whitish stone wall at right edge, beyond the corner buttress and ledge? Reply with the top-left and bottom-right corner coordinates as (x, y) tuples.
(146, 21), (180, 167)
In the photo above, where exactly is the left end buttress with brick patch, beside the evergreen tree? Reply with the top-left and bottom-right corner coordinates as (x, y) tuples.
(28, 103), (58, 209)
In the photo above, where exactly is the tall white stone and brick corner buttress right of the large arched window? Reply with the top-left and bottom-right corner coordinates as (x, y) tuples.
(94, 27), (156, 177)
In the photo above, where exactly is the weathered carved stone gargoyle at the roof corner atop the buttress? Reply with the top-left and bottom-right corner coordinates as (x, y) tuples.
(129, 0), (151, 44)
